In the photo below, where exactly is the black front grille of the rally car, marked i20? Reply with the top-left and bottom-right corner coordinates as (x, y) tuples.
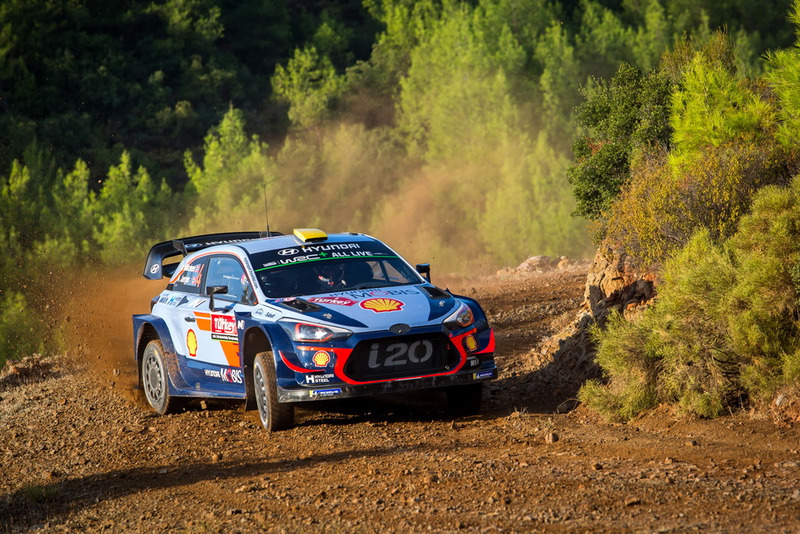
(344, 334), (459, 382)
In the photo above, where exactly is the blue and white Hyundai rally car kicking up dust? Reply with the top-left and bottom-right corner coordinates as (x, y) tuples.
(133, 229), (497, 430)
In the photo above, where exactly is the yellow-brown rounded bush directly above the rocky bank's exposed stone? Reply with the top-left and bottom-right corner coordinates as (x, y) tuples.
(605, 142), (787, 267)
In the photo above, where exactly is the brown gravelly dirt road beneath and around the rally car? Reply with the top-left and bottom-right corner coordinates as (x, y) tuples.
(0, 265), (800, 532)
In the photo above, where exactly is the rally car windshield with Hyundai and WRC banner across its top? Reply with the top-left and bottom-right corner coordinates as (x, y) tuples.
(251, 243), (422, 298)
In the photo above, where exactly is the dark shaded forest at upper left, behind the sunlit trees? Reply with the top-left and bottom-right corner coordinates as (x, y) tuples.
(0, 0), (378, 182)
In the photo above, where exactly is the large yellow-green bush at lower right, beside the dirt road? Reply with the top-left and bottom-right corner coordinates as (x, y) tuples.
(581, 176), (800, 420)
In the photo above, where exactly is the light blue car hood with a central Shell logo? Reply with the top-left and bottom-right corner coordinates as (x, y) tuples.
(272, 286), (459, 329)
